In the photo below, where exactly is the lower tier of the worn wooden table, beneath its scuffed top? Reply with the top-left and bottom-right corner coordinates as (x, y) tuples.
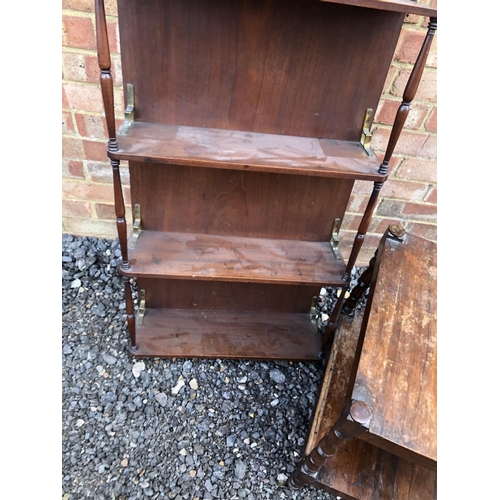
(291, 314), (437, 500)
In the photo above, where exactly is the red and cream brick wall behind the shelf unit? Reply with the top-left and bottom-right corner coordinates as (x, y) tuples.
(62, 0), (437, 265)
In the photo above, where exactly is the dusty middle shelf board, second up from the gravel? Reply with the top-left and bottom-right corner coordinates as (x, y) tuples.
(122, 231), (345, 286)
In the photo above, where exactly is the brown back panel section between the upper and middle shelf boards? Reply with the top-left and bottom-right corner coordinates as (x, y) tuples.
(129, 162), (353, 242)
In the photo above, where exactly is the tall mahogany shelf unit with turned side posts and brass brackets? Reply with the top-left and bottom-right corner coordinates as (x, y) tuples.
(95, 0), (436, 360)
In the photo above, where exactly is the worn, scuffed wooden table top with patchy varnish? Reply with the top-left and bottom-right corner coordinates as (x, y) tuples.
(352, 230), (437, 468)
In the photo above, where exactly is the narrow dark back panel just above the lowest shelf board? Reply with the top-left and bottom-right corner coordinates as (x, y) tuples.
(137, 277), (320, 314)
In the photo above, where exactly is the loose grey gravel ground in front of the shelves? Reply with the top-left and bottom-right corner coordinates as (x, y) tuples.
(62, 235), (361, 500)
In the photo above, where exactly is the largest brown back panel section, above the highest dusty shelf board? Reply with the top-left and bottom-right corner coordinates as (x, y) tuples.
(118, 0), (404, 141)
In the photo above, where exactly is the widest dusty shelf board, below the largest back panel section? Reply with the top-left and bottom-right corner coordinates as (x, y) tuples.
(108, 122), (387, 181)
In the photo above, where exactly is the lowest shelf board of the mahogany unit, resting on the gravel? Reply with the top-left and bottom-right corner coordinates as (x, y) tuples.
(131, 309), (321, 361)
